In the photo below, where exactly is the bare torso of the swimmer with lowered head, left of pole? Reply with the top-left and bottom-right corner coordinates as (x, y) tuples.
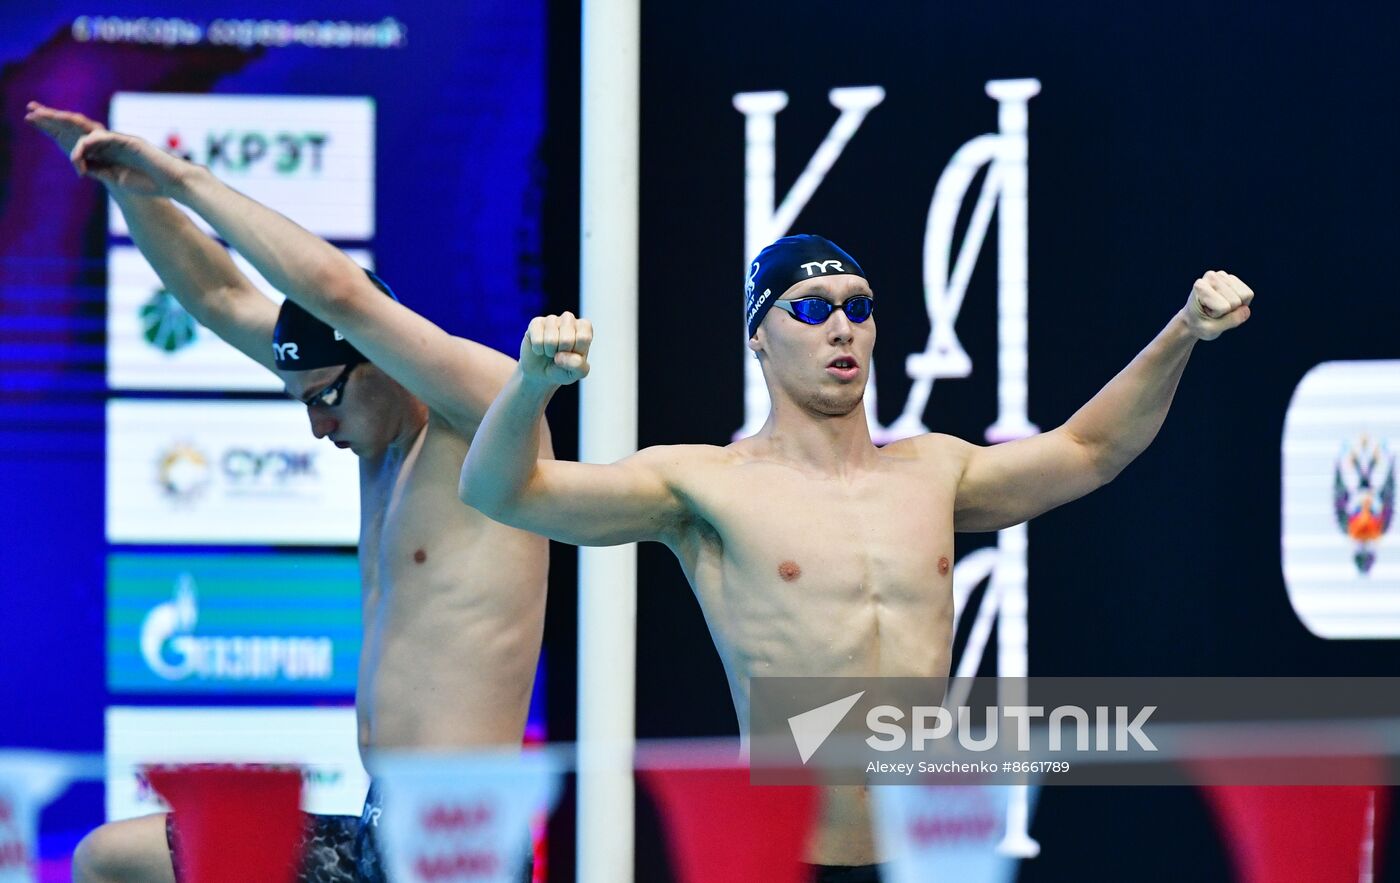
(356, 417), (549, 750)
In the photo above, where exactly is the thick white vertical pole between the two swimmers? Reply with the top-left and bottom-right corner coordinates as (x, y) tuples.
(578, 0), (641, 883)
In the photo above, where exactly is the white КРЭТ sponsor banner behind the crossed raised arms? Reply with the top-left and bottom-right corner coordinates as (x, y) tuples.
(108, 92), (375, 241)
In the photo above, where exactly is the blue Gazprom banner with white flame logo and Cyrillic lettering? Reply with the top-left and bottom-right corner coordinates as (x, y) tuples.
(106, 553), (361, 694)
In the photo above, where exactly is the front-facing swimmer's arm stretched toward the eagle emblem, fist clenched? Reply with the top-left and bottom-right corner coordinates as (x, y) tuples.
(955, 270), (1254, 530)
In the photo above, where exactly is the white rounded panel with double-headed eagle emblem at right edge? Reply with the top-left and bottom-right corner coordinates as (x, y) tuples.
(1282, 361), (1400, 638)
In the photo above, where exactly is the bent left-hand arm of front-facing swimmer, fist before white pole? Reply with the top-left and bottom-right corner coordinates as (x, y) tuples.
(458, 312), (686, 546)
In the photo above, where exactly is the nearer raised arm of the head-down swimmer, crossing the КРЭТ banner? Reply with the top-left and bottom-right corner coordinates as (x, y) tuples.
(73, 123), (512, 434)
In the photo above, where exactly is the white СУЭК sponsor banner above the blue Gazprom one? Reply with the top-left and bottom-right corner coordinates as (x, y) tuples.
(106, 399), (360, 546)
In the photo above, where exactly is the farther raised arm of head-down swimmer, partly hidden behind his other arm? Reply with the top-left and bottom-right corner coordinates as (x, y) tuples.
(24, 101), (277, 371)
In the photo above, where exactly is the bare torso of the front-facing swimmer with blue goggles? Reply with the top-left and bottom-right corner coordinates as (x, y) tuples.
(673, 437), (962, 865)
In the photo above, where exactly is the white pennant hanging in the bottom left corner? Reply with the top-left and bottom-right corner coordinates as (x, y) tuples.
(0, 751), (76, 883)
